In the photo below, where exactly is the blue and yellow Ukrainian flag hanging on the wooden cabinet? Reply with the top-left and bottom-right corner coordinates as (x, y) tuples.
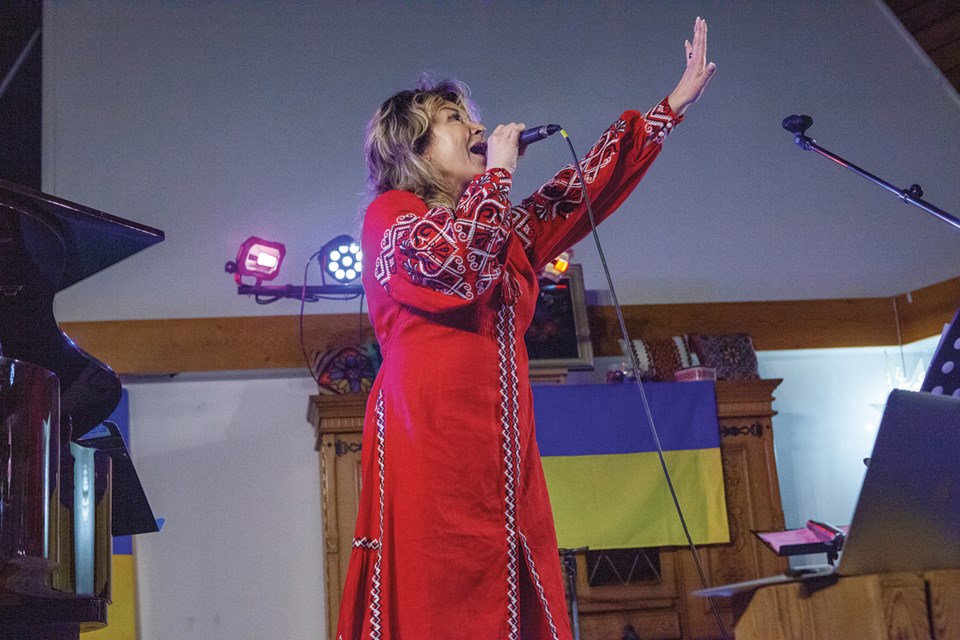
(533, 382), (730, 549)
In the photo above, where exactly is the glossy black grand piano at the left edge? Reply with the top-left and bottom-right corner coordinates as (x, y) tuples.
(0, 180), (163, 640)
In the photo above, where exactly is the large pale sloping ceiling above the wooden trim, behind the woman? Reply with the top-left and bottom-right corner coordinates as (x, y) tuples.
(43, 0), (960, 321)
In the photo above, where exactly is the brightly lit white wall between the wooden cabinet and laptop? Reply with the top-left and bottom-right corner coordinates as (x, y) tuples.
(758, 337), (938, 532)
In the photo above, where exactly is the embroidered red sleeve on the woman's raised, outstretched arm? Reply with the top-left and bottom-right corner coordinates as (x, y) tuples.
(510, 98), (683, 270)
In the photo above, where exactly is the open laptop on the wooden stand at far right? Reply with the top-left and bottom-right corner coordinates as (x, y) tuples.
(693, 389), (960, 597)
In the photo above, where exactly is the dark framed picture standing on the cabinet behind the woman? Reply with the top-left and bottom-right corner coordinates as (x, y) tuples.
(523, 264), (593, 370)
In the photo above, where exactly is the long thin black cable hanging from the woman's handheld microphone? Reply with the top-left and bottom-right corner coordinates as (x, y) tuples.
(560, 128), (730, 640)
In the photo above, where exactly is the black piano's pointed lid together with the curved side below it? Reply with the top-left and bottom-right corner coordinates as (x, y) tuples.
(0, 181), (163, 439)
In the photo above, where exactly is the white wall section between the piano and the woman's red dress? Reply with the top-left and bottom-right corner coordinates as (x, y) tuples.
(125, 373), (326, 640)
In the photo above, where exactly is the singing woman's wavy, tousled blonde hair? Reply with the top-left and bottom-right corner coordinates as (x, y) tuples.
(364, 75), (479, 207)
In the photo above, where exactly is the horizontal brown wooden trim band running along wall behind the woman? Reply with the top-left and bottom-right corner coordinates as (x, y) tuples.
(62, 277), (960, 375)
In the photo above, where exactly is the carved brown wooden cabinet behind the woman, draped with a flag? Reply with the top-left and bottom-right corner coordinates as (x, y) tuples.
(308, 380), (787, 640)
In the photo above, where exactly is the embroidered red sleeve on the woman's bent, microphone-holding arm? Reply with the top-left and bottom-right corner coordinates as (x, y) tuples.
(364, 169), (512, 313)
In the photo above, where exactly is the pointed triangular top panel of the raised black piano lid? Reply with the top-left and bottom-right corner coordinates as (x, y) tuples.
(0, 180), (163, 291)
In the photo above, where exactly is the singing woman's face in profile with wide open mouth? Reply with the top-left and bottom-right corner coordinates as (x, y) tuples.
(423, 102), (487, 197)
